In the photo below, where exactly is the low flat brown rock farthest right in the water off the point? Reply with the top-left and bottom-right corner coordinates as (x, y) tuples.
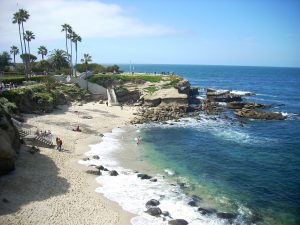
(235, 109), (286, 120)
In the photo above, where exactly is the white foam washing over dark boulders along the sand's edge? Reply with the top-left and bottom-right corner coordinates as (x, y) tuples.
(79, 128), (232, 225)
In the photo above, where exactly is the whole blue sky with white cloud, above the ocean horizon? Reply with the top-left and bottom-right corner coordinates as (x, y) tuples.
(0, 0), (300, 67)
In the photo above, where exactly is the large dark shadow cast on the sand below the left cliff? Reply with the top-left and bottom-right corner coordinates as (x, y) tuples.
(0, 149), (70, 216)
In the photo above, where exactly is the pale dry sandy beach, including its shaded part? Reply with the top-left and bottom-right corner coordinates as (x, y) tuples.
(0, 102), (136, 225)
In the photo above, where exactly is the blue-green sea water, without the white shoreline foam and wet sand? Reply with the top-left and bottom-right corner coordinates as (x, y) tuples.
(123, 65), (300, 225)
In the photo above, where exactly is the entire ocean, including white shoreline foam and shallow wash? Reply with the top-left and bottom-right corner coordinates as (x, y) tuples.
(81, 65), (300, 225)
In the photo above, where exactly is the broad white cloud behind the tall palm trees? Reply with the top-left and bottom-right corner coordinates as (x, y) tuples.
(0, 0), (180, 44)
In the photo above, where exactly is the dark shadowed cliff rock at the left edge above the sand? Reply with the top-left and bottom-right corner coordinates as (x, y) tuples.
(0, 105), (20, 175)
